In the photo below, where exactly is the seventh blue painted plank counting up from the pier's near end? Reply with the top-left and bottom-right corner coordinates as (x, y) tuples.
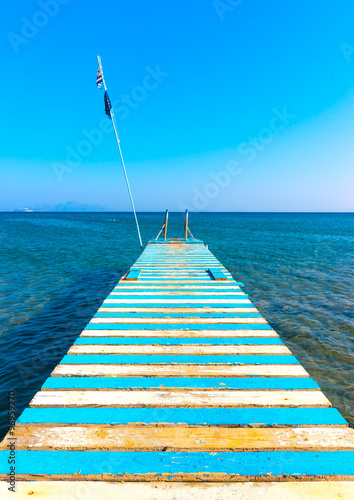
(94, 311), (262, 319)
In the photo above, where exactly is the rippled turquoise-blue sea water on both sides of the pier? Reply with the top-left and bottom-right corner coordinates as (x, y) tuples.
(0, 213), (354, 437)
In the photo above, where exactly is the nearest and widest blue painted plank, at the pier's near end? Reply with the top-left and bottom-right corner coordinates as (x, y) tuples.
(0, 450), (354, 479)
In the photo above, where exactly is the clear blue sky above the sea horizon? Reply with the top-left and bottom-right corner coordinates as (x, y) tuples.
(0, 0), (354, 211)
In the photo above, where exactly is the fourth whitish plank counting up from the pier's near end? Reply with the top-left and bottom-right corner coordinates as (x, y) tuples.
(52, 363), (309, 377)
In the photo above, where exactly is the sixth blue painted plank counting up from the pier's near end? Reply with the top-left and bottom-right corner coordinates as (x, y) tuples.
(85, 323), (272, 331)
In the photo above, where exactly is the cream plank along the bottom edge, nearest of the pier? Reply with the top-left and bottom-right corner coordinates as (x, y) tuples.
(0, 480), (354, 500)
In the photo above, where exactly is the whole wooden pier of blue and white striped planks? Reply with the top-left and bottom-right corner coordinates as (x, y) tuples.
(0, 225), (354, 500)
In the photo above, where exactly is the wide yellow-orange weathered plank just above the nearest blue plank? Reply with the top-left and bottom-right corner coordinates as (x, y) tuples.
(5, 425), (354, 454)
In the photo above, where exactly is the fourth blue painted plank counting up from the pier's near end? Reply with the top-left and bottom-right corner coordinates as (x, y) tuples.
(60, 354), (299, 365)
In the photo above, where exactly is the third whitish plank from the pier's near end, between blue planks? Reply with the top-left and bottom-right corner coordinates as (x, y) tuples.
(30, 389), (331, 408)
